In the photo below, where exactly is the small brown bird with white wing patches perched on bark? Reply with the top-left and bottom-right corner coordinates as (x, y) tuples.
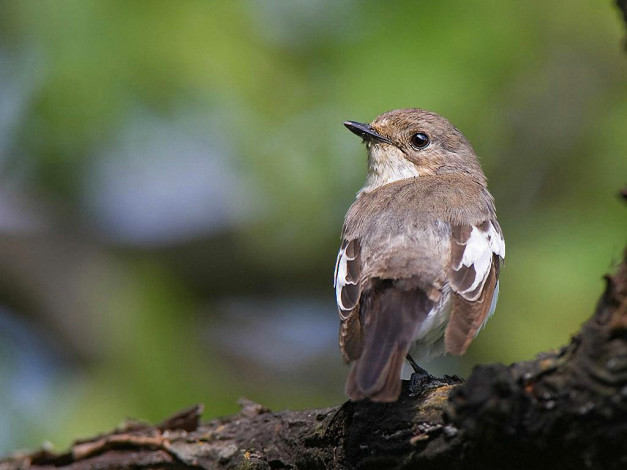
(335, 109), (505, 402)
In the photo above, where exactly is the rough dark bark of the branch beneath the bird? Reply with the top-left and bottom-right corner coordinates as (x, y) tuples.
(0, 244), (627, 470)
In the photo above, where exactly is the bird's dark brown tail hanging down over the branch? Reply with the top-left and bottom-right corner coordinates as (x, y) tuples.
(346, 281), (433, 402)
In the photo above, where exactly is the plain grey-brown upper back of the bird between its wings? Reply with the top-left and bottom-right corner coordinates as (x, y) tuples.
(344, 174), (494, 285)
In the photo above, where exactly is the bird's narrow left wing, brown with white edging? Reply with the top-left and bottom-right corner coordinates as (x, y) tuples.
(334, 239), (362, 362)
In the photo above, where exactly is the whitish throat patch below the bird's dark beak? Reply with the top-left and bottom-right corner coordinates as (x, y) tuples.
(357, 145), (420, 195)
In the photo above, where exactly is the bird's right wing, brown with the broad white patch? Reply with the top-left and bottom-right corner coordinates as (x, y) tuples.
(445, 220), (505, 355)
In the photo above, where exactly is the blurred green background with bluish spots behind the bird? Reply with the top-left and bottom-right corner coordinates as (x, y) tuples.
(0, 0), (627, 453)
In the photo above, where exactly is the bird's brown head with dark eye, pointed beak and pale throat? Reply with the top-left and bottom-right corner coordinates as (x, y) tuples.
(344, 108), (485, 192)
